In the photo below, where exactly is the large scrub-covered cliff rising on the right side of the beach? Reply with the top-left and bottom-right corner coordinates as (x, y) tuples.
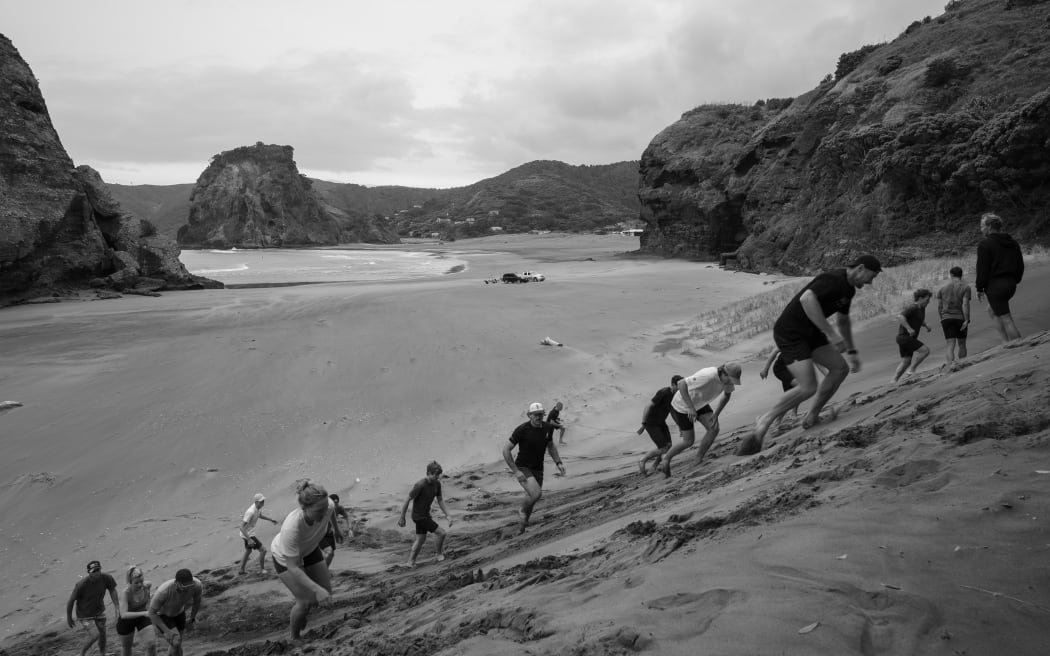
(639, 0), (1050, 273)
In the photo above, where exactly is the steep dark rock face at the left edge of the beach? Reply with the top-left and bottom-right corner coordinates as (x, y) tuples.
(0, 35), (222, 303)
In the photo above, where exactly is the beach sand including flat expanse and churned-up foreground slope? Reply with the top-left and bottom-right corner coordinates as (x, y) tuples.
(0, 234), (1050, 656)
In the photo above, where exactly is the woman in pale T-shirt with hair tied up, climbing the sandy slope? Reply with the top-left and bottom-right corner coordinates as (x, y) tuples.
(270, 480), (342, 640)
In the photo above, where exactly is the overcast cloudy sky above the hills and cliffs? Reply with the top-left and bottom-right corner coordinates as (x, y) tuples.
(0, 0), (946, 187)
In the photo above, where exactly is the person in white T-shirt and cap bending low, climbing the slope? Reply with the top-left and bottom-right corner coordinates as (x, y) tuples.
(656, 362), (743, 477)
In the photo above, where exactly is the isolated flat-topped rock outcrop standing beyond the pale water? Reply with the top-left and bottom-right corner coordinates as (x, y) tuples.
(179, 143), (398, 248)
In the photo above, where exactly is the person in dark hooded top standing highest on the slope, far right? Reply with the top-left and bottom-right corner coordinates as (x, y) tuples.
(974, 213), (1025, 342)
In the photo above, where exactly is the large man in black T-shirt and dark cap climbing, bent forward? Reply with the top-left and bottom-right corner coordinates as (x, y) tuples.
(737, 255), (882, 456)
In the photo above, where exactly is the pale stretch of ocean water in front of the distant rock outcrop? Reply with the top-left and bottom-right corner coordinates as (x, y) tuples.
(180, 249), (466, 287)
